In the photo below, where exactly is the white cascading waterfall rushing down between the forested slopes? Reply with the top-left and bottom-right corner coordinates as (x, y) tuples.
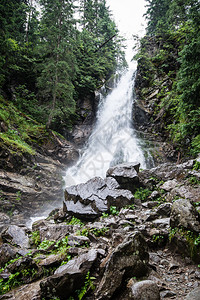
(64, 68), (152, 186)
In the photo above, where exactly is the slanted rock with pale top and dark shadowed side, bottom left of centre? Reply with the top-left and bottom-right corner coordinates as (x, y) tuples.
(40, 249), (97, 300)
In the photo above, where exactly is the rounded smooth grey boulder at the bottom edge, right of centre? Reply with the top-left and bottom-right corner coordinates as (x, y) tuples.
(124, 280), (160, 300)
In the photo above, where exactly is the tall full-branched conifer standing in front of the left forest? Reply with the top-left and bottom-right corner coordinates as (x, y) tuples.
(38, 0), (75, 127)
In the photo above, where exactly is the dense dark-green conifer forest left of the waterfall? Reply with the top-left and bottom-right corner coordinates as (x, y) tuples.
(0, 0), (125, 137)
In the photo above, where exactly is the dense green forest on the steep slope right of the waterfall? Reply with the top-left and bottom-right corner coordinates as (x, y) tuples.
(135, 0), (200, 155)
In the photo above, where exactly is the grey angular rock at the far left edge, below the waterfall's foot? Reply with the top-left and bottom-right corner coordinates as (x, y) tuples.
(1, 225), (29, 248)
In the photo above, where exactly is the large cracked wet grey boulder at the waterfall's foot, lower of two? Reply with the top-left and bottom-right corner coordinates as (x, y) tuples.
(63, 177), (134, 220)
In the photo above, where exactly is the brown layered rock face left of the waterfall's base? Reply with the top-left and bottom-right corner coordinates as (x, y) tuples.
(0, 138), (78, 225)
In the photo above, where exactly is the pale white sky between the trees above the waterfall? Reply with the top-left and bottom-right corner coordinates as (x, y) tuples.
(106, 0), (146, 61)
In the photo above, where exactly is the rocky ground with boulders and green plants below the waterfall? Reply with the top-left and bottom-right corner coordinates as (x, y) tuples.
(0, 158), (200, 300)
